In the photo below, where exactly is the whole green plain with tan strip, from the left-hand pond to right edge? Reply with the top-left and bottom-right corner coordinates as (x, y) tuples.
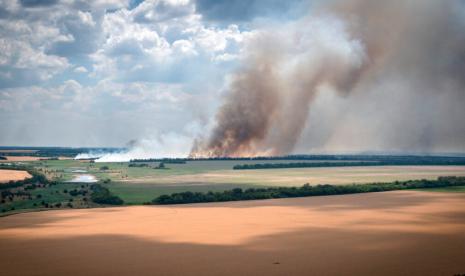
(32, 160), (465, 204)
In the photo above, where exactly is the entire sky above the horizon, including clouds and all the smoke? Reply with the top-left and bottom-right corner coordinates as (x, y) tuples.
(0, 0), (465, 160)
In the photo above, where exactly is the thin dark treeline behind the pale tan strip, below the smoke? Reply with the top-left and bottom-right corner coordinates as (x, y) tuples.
(233, 158), (465, 170)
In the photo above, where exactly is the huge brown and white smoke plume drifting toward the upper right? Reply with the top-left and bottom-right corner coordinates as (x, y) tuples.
(191, 0), (465, 156)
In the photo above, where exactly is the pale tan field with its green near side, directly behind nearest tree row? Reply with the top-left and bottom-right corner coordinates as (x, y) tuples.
(106, 166), (465, 204)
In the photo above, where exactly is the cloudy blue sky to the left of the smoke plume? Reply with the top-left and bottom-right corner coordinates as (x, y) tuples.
(0, 0), (308, 146)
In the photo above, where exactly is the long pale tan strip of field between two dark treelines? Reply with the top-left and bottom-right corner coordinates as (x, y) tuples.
(121, 166), (465, 186)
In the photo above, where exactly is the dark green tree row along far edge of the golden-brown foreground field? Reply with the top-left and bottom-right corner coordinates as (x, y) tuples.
(147, 176), (465, 205)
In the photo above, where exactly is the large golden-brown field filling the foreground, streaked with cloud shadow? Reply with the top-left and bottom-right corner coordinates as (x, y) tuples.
(0, 191), (465, 275)
